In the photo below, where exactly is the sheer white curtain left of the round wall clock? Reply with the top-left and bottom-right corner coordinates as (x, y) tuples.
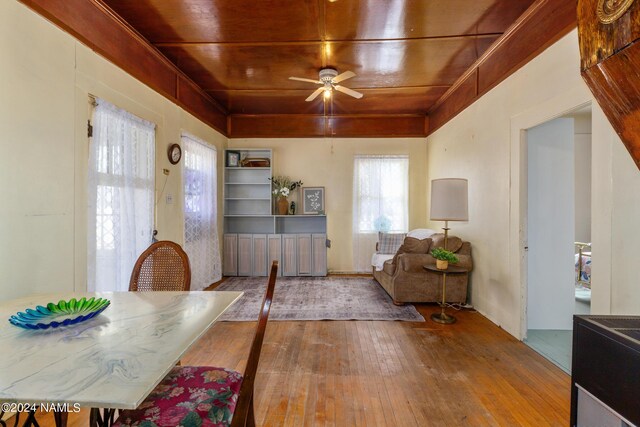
(87, 99), (155, 291)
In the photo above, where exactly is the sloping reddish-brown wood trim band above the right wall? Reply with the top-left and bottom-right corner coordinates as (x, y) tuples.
(427, 0), (577, 135)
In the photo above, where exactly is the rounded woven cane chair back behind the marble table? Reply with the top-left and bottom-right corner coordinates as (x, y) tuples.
(129, 240), (191, 291)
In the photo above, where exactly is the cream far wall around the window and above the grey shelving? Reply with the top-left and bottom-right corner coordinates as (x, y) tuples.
(229, 138), (427, 273)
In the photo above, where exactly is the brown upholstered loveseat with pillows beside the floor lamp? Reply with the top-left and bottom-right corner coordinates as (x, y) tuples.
(373, 230), (473, 305)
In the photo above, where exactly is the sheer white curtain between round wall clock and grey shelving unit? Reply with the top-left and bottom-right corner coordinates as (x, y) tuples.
(182, 135), (222, 290)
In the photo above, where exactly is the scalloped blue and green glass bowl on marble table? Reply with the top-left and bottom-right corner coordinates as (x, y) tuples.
(9, 297), (111, 329)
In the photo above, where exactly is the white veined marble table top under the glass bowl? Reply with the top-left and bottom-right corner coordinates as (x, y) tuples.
(0, 292), (242, 409)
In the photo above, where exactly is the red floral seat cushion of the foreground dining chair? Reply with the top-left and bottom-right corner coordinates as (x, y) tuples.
(113, 366), (242, 427)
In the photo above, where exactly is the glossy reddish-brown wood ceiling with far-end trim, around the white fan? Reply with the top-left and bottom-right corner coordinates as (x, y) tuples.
(96, 0), (534, 136)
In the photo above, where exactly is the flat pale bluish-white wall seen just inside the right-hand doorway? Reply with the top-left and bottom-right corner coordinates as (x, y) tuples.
(523, 118), (575, 330)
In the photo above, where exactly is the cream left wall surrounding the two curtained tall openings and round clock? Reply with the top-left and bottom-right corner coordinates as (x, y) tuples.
(0, 0), (226, 300)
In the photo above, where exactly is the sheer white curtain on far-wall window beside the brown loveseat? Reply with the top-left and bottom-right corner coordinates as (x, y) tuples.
(353, 155), (409, 272)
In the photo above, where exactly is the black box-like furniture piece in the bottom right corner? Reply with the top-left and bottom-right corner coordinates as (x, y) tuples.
(571, 316), (640, 426)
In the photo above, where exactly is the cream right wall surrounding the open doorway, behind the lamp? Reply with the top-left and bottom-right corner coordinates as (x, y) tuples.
(426, 30), (640, 338)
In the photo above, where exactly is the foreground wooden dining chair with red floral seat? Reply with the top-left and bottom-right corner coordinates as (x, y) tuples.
(113, 261), (278, 427)
